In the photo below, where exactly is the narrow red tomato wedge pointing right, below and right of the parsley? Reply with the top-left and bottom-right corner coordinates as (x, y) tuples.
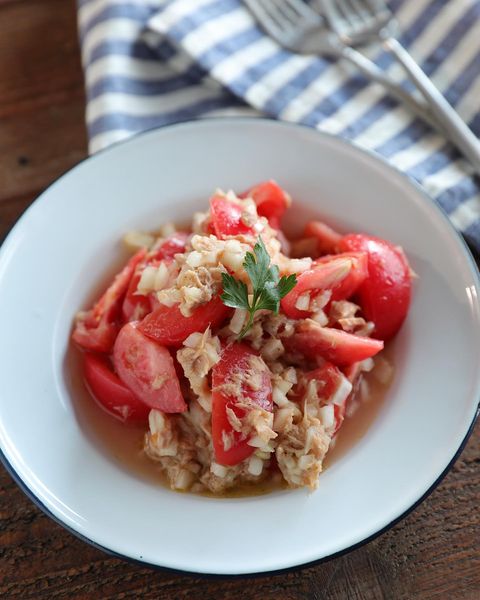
(286, 319), (383, 366)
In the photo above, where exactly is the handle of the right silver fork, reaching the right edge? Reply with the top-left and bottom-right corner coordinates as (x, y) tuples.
(382, 37), (480, 173)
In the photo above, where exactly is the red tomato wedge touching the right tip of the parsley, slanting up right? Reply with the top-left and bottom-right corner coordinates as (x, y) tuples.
(281, 253), (366, 319)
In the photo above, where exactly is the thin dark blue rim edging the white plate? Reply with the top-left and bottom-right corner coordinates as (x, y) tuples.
(0, 116), (480, 579)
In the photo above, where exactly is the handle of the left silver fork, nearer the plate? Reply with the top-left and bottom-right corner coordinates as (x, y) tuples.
(338, 46), (445, 134)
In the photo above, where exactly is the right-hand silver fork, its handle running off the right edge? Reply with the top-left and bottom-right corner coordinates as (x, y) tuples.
(319, 0), (480, 173)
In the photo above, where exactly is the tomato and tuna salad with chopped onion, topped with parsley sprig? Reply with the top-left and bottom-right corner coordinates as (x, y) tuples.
(72, 181), (412, 494)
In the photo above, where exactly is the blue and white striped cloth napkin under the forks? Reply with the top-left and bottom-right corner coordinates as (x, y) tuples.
(77, 0), (480, 251)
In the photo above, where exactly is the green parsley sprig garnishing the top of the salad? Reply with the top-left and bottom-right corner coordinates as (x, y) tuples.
(220, 237), (297, 340)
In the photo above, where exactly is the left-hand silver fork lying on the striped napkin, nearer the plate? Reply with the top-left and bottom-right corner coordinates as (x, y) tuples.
(243, 0), (438, 133)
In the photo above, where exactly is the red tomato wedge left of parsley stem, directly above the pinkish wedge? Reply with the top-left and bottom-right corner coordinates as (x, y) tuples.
(138, 296), (231, 347)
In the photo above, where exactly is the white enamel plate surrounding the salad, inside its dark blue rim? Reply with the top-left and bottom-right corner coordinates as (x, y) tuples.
(0, 119), (480, 574)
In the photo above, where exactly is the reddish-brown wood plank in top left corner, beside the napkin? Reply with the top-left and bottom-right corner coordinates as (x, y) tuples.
(0, 0), (86, 202)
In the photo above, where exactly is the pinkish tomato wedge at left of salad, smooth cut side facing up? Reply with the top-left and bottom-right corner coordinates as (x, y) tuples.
(113, 322), (187, 413)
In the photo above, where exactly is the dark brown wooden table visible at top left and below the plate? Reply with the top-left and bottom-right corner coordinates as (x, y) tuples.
(0, 0), (480, 600)
